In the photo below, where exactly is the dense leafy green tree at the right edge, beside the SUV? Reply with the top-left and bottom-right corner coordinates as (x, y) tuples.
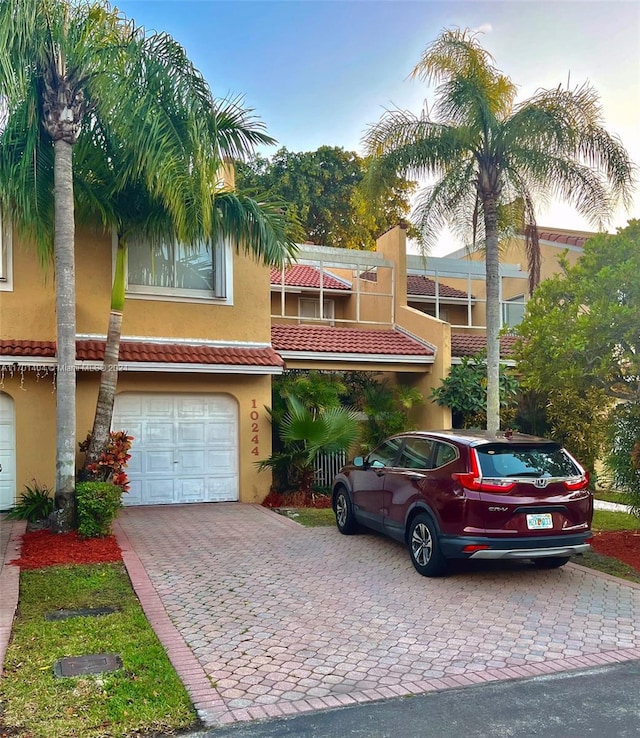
(514, 220), (640, 494)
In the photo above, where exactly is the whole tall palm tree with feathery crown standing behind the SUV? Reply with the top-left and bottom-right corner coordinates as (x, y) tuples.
(366, 29), (633, 433)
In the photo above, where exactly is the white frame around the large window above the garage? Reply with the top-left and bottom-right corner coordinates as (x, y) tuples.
(122, 233), (233, 305)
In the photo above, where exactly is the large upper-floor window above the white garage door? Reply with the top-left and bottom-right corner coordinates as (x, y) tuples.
(127, 241), (226, 298)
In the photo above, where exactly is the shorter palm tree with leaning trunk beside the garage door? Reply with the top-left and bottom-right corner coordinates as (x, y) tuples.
(76, 114), (297, 475)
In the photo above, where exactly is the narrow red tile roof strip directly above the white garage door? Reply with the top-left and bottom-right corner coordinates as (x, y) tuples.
(0, 339), (284, 367)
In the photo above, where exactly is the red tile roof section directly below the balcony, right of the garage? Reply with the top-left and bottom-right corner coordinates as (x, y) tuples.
(271, 324), (434, 356)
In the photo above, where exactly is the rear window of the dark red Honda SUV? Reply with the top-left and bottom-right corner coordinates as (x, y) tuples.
(476, 444), (581, 479)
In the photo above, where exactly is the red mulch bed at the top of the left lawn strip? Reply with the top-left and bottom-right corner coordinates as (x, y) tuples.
(11, 530), (122, 569)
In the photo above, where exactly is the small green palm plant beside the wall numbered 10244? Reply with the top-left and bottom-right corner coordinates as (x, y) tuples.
(258, 396), (360, 497)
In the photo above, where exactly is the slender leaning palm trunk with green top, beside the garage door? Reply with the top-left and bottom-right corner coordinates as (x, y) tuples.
(82, 237), (127, 476)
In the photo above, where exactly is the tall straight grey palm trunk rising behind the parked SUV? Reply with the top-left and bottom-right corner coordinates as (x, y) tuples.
(483, 196), (500, 434)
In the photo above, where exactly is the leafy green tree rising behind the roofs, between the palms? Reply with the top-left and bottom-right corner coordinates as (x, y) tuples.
(237, 146), (416, 249)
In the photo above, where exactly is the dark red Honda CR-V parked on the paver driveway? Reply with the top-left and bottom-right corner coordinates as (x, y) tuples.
(333, 430), (593, 576)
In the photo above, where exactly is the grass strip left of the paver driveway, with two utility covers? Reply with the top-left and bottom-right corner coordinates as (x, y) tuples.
(0, 564), (196, 738)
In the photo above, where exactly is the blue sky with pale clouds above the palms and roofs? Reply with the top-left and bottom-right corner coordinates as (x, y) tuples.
(114, 0), (640, 254)
